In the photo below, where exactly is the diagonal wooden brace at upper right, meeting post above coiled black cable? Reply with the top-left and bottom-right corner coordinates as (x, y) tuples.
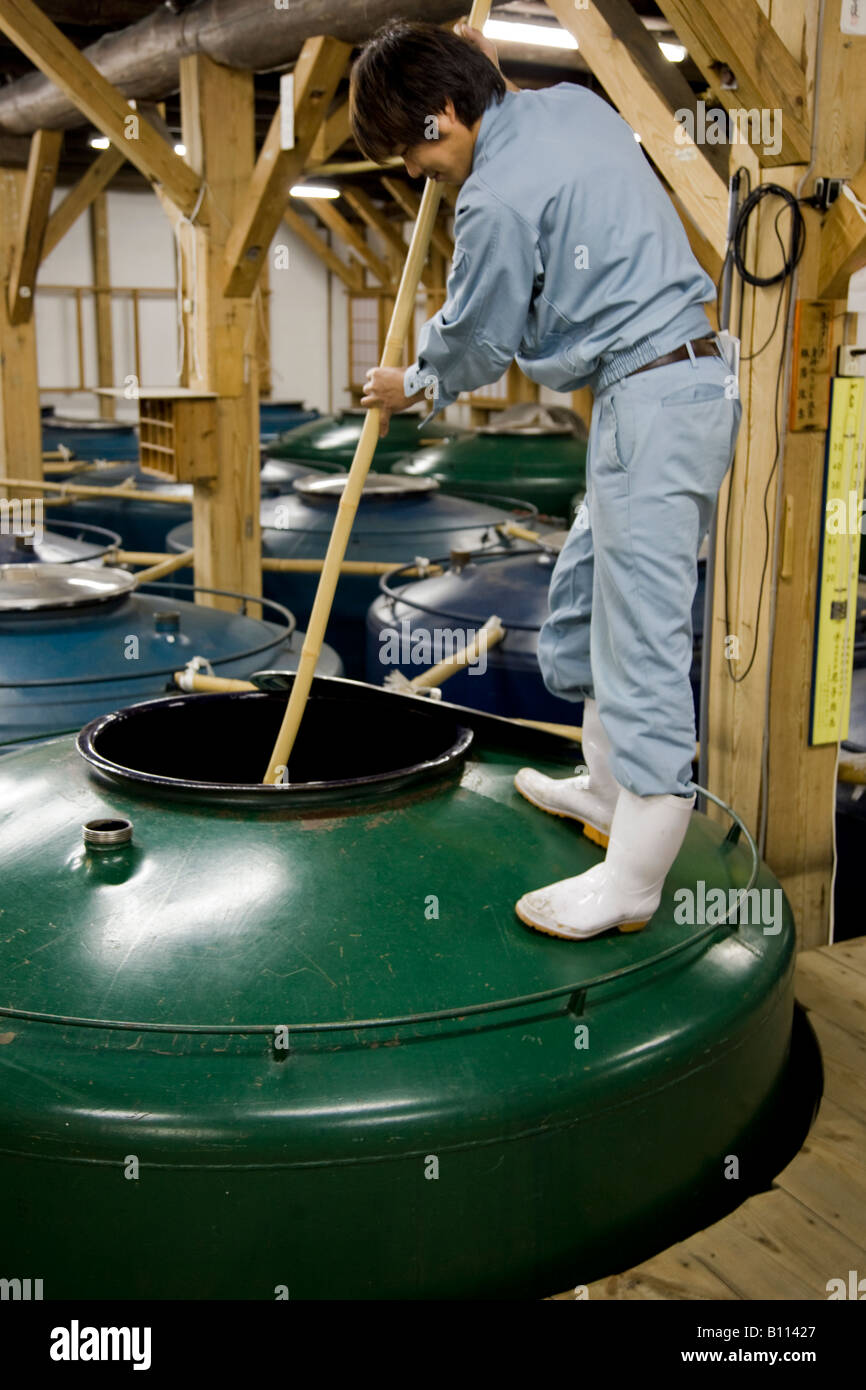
(659, 0), (812, 165)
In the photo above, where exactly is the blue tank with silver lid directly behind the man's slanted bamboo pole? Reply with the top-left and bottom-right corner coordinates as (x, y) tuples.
(168, 473), (535, 680)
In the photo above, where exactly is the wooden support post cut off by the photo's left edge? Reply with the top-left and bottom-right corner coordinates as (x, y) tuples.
(0, 168), (42, 498)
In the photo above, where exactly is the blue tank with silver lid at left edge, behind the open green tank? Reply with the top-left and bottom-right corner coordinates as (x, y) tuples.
(0, 564), (342, 751)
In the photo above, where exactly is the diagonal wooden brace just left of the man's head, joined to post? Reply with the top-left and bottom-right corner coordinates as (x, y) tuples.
(223, 35), (352, 299)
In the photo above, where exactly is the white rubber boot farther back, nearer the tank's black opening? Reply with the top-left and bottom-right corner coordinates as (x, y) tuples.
(514, 699), (620, 849)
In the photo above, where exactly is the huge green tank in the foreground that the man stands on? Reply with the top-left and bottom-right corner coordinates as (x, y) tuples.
(0, 678), (799, 1300)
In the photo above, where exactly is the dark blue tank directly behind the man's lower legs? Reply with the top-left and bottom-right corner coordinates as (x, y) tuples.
(366, 532), (703, 724)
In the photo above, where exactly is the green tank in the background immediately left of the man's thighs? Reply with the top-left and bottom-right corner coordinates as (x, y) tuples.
(394, 404), (587, 517)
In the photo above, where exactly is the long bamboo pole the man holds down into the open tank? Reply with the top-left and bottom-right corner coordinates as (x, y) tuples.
(264, 0), (491, 783)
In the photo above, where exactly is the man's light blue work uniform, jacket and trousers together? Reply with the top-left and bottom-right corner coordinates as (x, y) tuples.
(405, 83), (741, 795)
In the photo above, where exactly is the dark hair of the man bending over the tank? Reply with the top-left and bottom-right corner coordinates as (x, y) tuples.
(349, 19), (505, 164)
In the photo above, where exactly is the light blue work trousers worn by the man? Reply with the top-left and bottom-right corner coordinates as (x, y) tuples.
(538, 357), (741, 796)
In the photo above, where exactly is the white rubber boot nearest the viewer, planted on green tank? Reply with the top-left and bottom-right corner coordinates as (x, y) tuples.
(514, 790), (695, 941)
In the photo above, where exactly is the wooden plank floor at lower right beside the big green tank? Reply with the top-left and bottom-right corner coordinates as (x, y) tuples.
(560, 937), (866, 1301)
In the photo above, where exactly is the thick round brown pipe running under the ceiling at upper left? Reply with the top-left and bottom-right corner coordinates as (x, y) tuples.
(0, 0), (466, 135)
